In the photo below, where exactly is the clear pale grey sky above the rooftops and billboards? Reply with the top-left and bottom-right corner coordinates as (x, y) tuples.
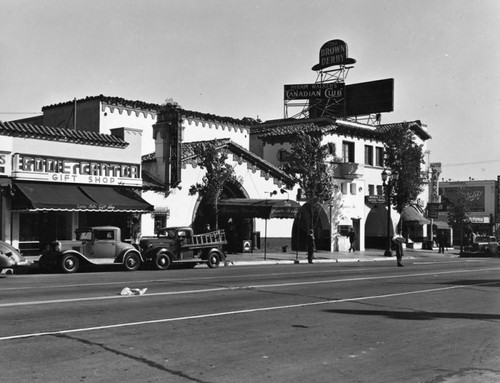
(0, 0), (500, 180)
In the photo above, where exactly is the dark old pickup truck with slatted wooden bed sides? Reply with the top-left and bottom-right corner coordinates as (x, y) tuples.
(140, 227), (227, 270)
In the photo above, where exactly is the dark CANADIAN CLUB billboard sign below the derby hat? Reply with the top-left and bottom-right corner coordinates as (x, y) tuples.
(284, 82), (345, 101)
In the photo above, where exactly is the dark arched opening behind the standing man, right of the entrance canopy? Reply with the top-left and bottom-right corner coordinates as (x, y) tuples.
(292, 202), (331, 251)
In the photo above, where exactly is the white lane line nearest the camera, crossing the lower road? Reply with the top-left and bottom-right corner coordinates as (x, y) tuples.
(0, 281), (498, 341)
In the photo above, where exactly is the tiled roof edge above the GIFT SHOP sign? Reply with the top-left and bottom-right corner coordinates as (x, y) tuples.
(0, 121), (128, 148)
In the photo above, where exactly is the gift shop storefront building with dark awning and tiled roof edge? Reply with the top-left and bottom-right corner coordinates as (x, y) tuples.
(0, 122), (153, 254)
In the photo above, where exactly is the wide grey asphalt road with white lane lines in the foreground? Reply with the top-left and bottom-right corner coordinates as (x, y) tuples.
(0, 258), (500, 383)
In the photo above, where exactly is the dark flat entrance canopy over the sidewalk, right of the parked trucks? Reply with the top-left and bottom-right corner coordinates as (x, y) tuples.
(217, 198), (300, 219)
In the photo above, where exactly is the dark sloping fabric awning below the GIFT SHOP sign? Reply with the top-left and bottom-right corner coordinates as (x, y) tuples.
(12, 182), (154, 213)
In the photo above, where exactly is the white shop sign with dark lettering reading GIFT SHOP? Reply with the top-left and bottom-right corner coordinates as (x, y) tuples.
(12, 153), (142, 186)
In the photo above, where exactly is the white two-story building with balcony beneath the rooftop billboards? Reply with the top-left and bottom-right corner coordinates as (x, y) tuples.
(250, 117), (430, 254)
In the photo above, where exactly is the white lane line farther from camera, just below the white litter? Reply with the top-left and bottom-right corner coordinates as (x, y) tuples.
(0, 268), (500, 308)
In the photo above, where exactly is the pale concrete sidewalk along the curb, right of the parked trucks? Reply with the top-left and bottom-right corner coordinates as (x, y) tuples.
(227, 248), (458, 266)
